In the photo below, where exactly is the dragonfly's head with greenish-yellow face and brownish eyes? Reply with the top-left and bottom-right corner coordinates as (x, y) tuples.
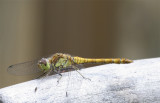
(38, 58), (50, 71)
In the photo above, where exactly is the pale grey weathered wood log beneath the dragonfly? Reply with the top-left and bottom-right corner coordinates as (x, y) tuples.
(0, 58), (160, 103)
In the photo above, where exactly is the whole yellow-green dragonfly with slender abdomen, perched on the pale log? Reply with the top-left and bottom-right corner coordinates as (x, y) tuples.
(7, 53), (133, 81)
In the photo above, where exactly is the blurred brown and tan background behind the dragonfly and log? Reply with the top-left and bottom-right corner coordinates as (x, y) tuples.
(0, 0), (160, 88)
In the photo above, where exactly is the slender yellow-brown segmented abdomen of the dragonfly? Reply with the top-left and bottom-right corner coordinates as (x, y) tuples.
(73, 57), (133, 64)
